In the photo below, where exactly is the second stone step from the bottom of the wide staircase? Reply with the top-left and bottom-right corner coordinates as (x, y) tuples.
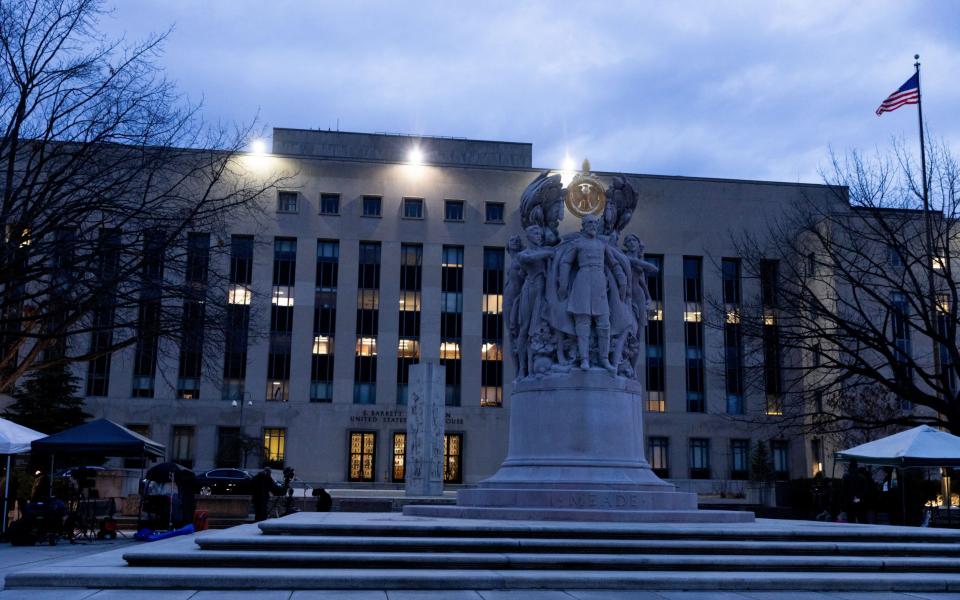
(123, 550), (960, 573)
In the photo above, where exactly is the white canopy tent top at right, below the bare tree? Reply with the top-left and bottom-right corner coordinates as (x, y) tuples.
(834, 425), (960, 468)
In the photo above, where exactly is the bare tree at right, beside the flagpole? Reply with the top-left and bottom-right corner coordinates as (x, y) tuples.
(717, 138), (960, 435)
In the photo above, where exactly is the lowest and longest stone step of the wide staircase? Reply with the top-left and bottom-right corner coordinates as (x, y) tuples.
(6, 566), (960, 597)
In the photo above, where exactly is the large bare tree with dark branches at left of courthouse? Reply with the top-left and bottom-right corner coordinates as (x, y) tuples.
(0, 0), (278, 392)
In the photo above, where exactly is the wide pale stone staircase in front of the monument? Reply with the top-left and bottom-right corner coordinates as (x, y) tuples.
(7, 513), (960, 592)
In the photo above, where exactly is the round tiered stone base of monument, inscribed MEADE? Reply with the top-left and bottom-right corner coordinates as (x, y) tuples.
(404, 369), (753, 523)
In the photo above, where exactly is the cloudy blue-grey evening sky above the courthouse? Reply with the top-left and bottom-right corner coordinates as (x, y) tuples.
(102, 0), (960, 182)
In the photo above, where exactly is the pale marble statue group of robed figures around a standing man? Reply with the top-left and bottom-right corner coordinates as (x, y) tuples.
(504, 162), (653, 379)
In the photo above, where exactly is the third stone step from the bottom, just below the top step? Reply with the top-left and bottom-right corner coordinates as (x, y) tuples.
(197, 535), (960, 557)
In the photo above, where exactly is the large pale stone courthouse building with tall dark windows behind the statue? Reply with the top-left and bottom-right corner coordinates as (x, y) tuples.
(71, 129), (844, 492)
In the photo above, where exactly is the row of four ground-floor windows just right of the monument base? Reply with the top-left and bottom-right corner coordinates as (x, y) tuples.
(647, 436), (790, 480)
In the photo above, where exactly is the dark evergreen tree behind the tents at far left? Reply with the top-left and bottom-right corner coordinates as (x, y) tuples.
(2, 362), (90, 434)
